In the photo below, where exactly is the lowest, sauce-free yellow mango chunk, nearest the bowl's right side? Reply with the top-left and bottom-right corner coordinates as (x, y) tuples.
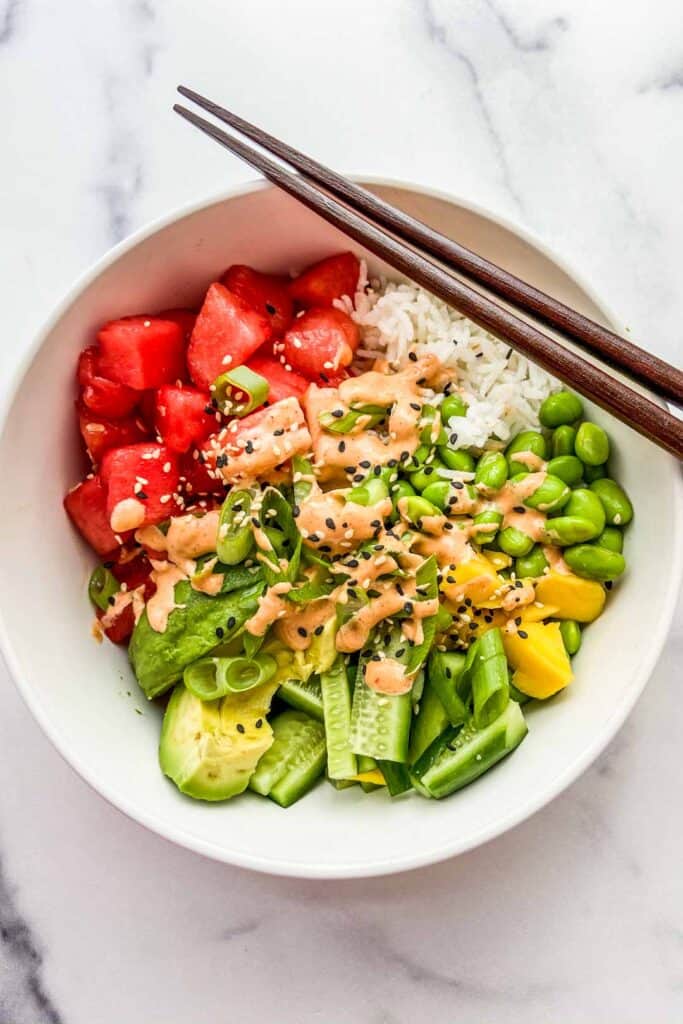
(503, 623), (573, 699)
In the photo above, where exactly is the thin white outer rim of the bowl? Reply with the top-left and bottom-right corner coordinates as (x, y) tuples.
(0, 173), (683, 880)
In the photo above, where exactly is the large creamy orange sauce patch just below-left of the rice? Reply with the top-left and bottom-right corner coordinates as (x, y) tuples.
(303, 355), (440, 480)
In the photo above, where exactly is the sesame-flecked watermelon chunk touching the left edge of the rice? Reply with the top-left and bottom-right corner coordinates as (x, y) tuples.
(284, 307), (360, 381)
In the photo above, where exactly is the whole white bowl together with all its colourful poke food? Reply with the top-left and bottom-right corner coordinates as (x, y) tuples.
(0, 179), (682, 878)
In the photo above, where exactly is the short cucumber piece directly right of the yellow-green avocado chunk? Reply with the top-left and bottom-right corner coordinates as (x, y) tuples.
(249, 711), (326, 807)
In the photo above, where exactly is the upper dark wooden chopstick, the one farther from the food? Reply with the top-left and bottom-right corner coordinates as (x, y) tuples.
(178, 85), (683, 404)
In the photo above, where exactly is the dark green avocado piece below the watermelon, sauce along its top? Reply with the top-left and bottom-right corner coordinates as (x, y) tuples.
(128, 577), (263, 699)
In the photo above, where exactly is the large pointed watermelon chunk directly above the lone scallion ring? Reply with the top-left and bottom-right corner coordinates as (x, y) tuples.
(187, 283), (272, 390)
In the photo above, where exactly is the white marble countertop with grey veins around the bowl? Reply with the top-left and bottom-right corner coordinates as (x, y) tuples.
(0, 0), (683, 1024)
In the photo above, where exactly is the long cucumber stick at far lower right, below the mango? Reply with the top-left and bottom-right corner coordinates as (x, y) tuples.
(412, 700), (528, 800)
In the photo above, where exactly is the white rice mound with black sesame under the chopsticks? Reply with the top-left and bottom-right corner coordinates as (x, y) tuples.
(338, 262), (560, 449)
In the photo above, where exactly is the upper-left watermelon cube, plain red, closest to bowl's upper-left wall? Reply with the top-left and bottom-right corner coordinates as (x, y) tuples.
(97, 316), (185, 391)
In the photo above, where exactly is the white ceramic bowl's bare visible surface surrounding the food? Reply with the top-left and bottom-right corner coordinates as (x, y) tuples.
(0, 182), (682, 878)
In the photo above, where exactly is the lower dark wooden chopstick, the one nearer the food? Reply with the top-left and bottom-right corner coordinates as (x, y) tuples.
(173, 103), (683, 459)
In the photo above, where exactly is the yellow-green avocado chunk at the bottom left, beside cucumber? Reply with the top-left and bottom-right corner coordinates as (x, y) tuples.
(159, 683), (278, 801)
